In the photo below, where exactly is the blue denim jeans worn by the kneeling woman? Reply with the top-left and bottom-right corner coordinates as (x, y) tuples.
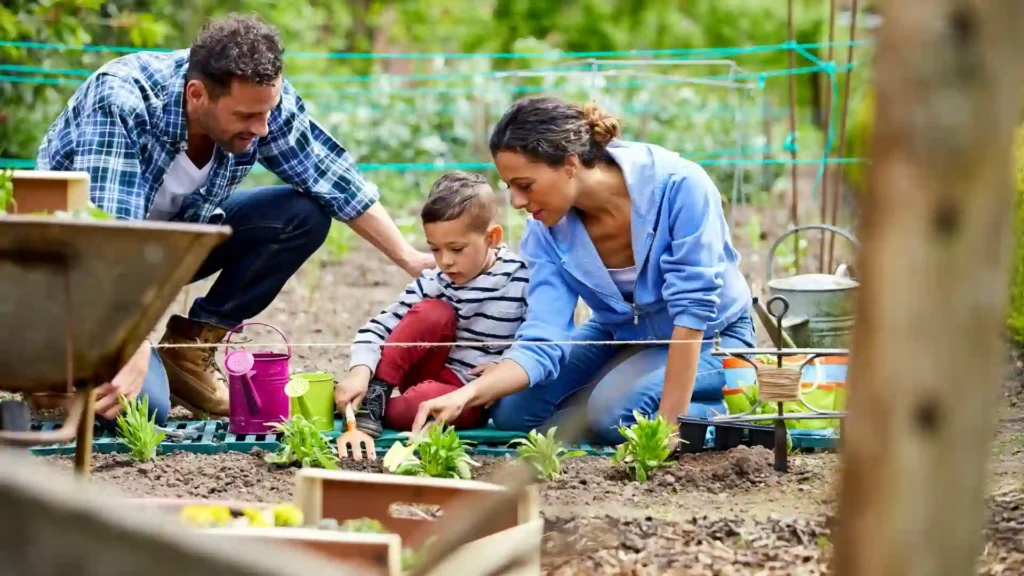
(490, 313), (755, 445)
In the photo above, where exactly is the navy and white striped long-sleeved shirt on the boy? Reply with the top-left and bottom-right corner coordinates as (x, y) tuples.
(349, 244), (529, 382)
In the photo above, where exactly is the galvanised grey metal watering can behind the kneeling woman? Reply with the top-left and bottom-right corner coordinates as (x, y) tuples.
(758, 224), (860, 348)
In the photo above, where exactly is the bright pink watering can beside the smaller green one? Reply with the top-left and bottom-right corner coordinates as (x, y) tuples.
(224, 322), (292, 435)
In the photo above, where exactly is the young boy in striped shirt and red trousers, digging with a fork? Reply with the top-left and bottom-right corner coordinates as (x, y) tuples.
(335, 171), (527, 438)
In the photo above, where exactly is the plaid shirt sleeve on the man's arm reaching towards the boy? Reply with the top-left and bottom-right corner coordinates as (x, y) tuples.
(259, 81), (380, 221)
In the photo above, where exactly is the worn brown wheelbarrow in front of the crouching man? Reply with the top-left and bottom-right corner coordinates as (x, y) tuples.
(0, 215), (230, 474)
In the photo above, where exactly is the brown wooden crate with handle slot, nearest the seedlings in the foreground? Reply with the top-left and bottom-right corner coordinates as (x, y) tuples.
(295, 468), (544, 576)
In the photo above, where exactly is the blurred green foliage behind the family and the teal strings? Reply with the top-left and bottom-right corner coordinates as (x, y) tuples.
(0, 0), (870, 256)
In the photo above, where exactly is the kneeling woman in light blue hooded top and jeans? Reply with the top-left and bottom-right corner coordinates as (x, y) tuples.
(413, 97), (755, 444)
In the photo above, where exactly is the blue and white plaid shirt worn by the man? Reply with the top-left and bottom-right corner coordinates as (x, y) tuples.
(36, 50), (380, 223)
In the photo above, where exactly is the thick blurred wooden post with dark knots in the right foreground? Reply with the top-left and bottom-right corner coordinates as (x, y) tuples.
(835, 0), (1024, 576)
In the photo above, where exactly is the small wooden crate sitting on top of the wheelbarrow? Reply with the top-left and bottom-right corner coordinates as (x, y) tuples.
(10, 170), (89, 214)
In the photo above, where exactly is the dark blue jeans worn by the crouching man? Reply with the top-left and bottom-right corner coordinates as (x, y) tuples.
(100, 186), (331, 425)
